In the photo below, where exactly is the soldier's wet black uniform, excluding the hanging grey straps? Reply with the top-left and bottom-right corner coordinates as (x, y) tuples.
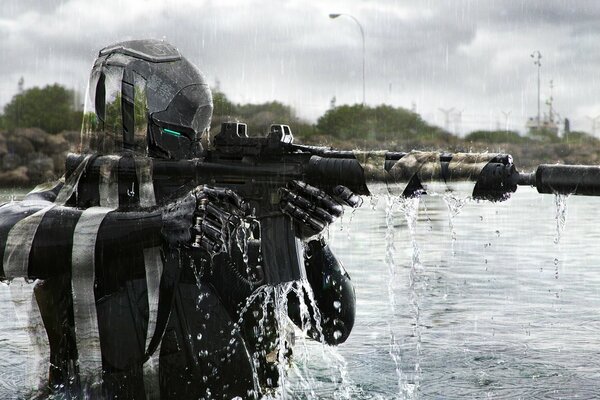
(0, 166), (354, 399)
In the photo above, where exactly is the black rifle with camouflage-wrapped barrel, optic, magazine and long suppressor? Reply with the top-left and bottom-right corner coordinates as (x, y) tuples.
(67, 122), (600, 284)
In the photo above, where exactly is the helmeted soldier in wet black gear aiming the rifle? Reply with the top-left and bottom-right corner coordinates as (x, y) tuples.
(0, 40), (360, 399)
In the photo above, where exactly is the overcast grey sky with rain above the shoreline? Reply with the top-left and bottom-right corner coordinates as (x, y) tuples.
(0, 0), (600, 135)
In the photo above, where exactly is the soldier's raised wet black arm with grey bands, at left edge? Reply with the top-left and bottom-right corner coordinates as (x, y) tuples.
(0, 200), (162, 279)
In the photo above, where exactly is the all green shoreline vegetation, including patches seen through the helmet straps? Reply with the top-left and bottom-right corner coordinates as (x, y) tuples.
(0, 84), (600, 167)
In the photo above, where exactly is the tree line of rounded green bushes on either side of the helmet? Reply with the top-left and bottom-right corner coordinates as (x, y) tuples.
(0, 84), (597, 147)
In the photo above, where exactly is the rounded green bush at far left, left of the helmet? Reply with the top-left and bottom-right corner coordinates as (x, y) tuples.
(0, 84), (82, 133)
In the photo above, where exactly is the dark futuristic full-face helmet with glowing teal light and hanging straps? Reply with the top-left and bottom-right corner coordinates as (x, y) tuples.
(81, 39), (213, 159)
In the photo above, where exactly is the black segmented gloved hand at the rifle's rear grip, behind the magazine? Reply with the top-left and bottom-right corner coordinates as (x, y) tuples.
(192, 185), (250, 256)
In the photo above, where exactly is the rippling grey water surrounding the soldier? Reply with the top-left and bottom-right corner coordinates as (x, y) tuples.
(0, 188), (600, 399)
